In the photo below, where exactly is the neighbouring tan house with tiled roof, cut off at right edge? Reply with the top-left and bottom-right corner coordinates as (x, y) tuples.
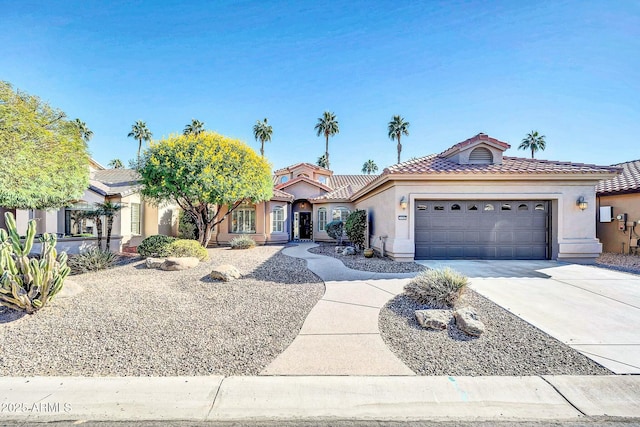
(596, 160), (640, 253)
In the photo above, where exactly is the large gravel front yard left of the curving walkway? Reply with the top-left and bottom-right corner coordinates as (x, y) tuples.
(0, 246), (324, 376)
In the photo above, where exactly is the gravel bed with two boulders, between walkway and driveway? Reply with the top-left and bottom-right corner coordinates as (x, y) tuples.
(378, 289), (612, 376)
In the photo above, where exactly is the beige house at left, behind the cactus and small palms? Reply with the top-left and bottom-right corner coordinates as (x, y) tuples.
(0, 160), (178, 253)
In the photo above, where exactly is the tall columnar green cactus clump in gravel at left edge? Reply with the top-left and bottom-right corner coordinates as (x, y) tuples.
(0, 212), (71, 314)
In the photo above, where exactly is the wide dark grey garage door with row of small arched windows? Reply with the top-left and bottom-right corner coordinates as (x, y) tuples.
(415, 200), (550, 259)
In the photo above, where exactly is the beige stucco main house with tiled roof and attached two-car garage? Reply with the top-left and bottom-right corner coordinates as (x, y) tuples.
(215, 133), (619, 262)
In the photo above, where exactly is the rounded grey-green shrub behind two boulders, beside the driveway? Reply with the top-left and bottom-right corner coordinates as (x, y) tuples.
(404, 267), (469, 308)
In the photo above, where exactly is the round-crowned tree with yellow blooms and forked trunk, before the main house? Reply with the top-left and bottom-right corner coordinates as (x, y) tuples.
(139, 132), (273, 247)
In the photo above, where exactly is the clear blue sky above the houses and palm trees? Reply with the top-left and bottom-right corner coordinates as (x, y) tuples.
(0, 0), (640, 173)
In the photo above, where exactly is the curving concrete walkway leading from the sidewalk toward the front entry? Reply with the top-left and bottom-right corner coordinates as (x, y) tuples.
(261, 243), (415, 375)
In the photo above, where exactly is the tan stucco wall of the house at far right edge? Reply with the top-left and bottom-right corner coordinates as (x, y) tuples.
(596, 193), (640, 253)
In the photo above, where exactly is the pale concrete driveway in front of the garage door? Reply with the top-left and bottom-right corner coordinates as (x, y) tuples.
(419, 260), (640, 374)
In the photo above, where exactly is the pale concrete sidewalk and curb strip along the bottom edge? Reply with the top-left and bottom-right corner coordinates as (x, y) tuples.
(0, 376), (640, 422)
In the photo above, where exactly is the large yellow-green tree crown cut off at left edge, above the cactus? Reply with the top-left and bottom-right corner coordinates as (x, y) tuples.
(0, 81), (89, 209)
